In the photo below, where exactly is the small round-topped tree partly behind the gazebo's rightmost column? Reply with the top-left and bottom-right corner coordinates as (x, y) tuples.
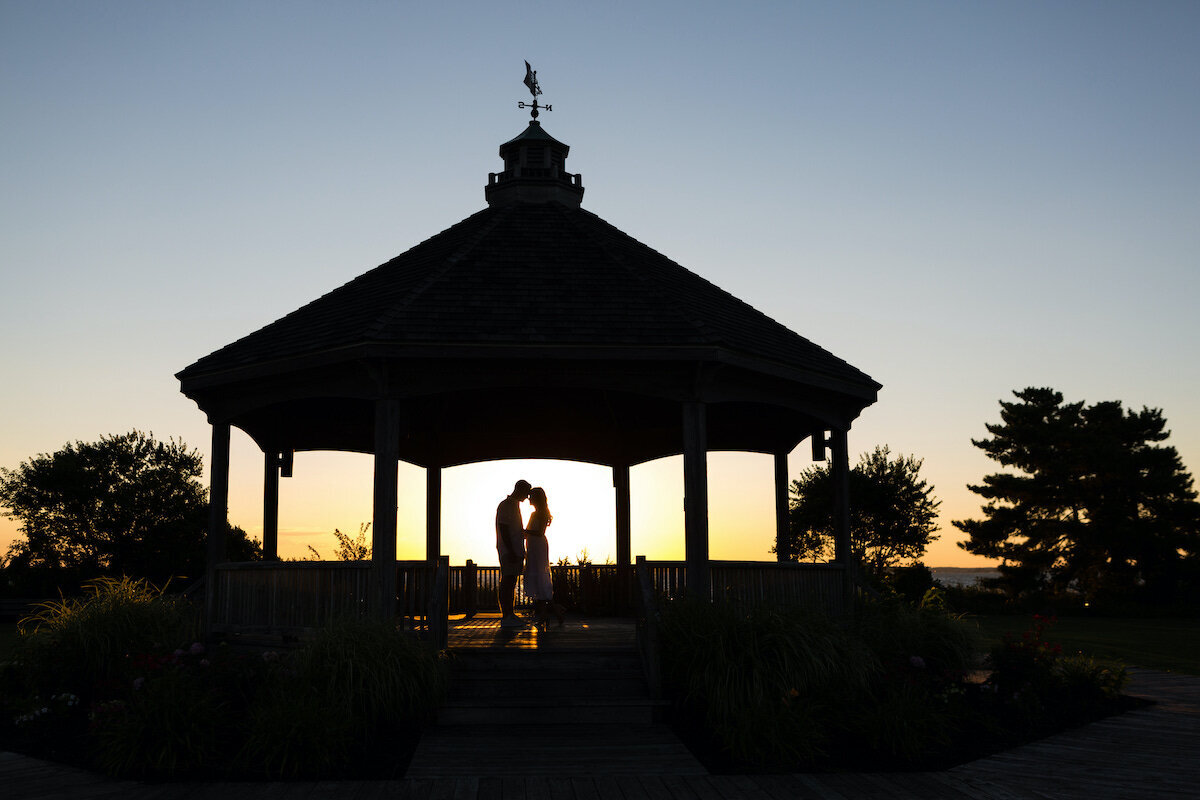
(773, 445), (941, 577)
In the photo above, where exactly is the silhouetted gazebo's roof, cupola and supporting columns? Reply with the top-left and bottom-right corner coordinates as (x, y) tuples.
(176, 98), (881, 633)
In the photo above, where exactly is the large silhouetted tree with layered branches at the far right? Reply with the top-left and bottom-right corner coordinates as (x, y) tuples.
(954, 387), (1200, 597)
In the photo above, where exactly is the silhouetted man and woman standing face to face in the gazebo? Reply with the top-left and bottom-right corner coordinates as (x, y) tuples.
(496, 481), (563, 627)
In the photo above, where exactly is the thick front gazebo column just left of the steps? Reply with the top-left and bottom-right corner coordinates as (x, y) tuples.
(371, 397), (400, 619)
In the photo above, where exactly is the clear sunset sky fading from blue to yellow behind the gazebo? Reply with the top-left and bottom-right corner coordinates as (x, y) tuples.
(0, 0), (1200, 566)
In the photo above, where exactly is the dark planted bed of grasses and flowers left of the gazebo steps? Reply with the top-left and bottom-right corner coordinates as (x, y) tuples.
(0, 581), (445, 778)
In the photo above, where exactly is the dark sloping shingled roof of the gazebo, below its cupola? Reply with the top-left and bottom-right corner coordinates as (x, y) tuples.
(178, 196), (877, 393)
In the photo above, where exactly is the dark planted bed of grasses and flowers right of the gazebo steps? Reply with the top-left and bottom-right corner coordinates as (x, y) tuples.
(662, 596), (1138, 772)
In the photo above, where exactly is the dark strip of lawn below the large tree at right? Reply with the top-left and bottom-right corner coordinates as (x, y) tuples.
(968, 616), (1200, 675)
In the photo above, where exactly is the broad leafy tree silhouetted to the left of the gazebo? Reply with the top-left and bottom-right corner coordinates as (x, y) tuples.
(0, 431), (262, 582)
